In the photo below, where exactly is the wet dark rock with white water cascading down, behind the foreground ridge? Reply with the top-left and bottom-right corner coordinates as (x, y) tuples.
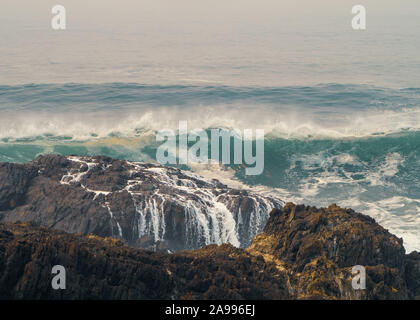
(0, 155), (283, 252)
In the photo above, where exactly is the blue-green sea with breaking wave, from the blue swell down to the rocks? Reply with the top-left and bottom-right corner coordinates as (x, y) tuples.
(0, 83), (420, 251)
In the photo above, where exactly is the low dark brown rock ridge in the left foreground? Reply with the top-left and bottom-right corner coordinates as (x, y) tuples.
(0, 223), (289, 299)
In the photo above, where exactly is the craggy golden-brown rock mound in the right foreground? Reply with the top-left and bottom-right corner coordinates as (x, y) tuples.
(247, 203), (420, 299)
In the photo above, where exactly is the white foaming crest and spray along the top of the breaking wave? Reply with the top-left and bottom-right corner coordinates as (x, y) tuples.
(0, 106), (420, 142)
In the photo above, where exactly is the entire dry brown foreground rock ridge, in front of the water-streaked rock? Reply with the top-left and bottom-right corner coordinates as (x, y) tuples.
(0, 203), (420, 299)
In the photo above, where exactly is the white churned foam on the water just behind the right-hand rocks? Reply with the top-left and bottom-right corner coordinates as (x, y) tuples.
(192, 152), (420, 252)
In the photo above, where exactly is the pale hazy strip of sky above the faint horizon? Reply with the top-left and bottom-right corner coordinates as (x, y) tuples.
(0, 0), (420, 29)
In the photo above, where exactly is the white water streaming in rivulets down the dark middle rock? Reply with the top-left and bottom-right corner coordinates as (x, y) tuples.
(61, 157), (283, 248)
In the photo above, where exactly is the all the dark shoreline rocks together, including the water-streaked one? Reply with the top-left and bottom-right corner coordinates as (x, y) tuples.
(0, 155), (420, 299)
